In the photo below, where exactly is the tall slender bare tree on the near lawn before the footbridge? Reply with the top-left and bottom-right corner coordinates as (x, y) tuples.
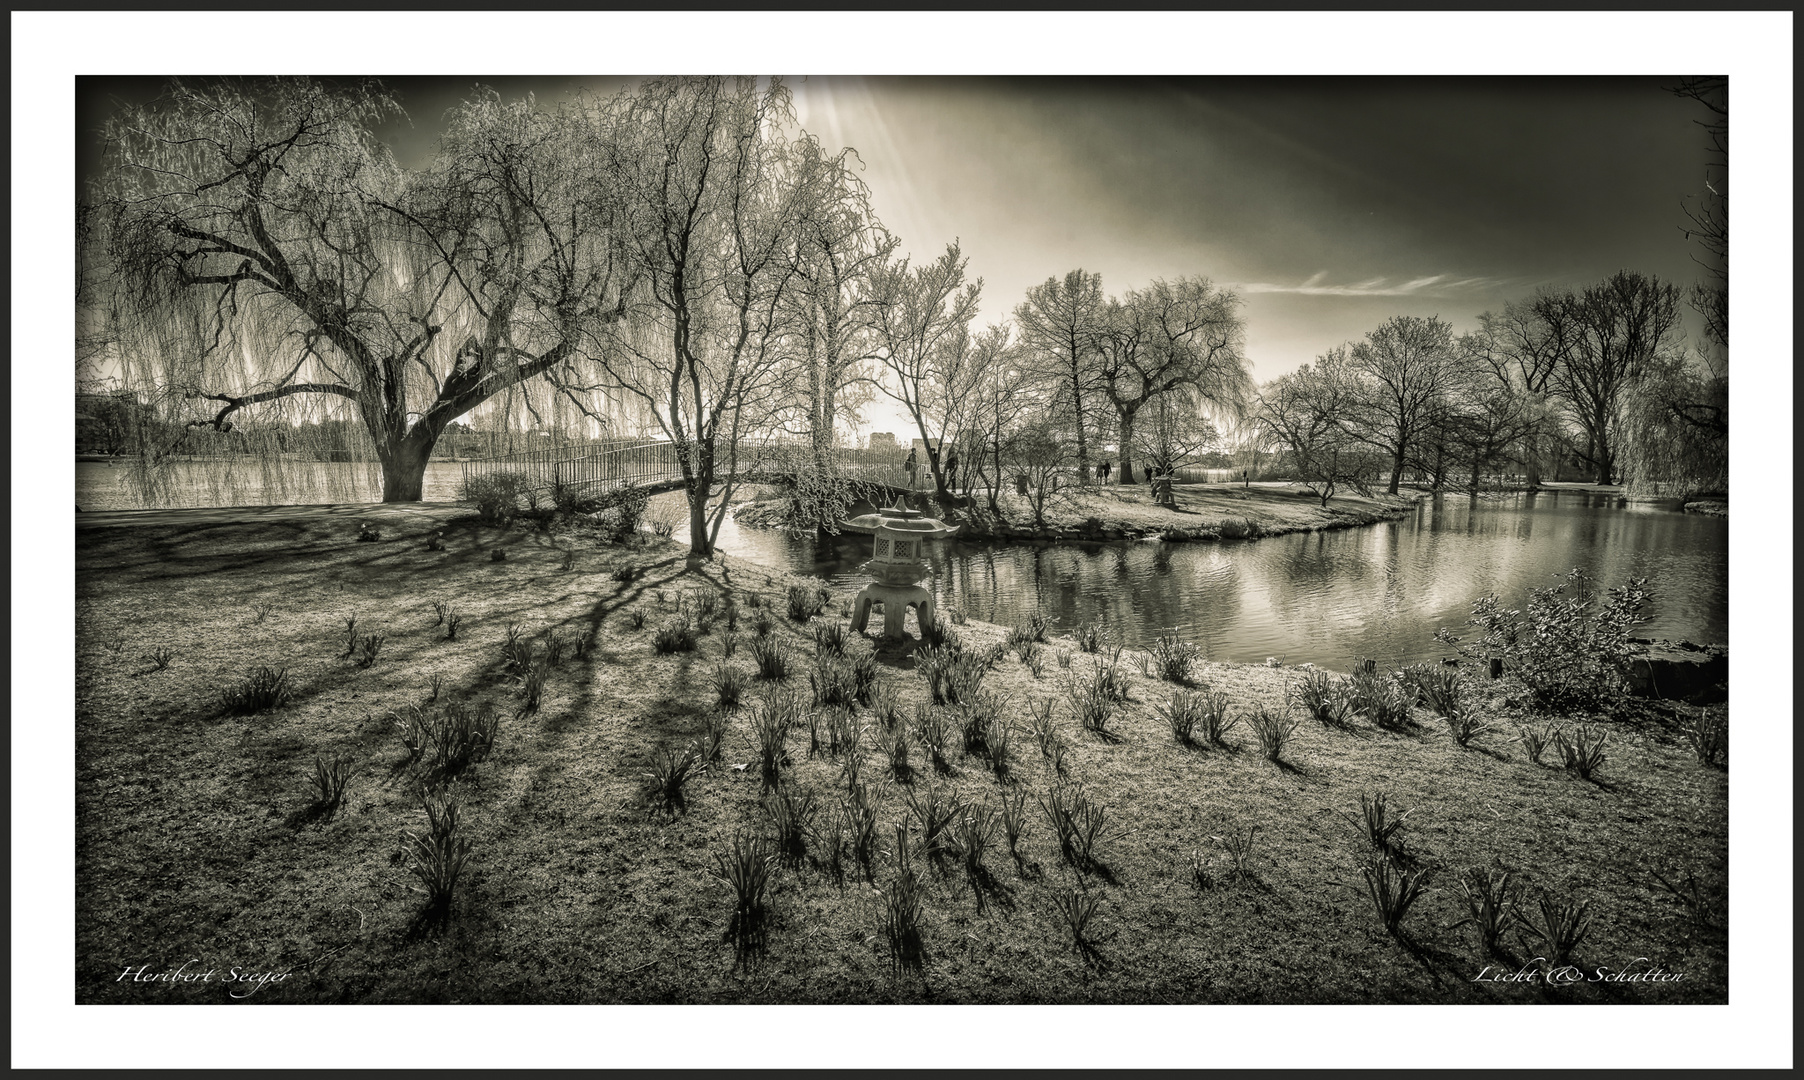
(594, 78), (819, 559)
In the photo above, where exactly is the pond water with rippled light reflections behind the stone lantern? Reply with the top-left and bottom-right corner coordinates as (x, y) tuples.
(703, 492), (1728, 669)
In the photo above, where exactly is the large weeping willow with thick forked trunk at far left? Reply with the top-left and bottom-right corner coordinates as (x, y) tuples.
(85, 79), (631, 501)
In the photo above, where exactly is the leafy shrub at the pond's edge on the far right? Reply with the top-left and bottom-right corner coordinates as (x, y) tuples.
(1434, 568), (1647, 712)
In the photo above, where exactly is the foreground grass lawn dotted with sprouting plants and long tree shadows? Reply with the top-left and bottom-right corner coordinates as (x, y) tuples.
(76, 508), (1728, 1004)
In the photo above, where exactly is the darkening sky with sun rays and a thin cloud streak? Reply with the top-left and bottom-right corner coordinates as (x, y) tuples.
(78, 70), (1708, 438)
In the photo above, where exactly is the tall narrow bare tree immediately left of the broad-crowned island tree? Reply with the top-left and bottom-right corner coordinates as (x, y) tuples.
(1016, 269), (1104, 481)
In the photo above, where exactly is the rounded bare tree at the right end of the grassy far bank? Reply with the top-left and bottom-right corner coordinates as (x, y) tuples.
(1349, 316), (1458, 496)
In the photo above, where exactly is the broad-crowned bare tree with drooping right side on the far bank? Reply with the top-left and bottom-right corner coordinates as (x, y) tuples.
(1097, 278), (1252, 483)
